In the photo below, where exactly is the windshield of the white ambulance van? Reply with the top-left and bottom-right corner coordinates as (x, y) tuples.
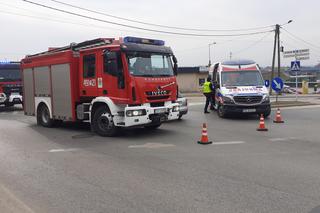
(221, 71), (264, 87)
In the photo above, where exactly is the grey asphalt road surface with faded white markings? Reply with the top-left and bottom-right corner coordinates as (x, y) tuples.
(0, 105), (320, 213)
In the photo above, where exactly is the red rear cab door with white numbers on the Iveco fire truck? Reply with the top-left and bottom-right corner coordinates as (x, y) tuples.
(80, 53), (98, 97)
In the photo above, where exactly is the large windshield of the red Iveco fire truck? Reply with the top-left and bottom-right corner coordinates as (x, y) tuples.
(127, 52), (174, 77)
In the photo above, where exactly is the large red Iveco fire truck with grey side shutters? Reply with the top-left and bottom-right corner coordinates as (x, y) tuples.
(21, 37), (179, 136)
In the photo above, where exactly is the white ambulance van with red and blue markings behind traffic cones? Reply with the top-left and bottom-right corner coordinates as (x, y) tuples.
(209, 60), (271, 117)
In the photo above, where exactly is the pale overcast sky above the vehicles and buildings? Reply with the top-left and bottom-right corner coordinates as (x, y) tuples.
(0, 0), (320, 66)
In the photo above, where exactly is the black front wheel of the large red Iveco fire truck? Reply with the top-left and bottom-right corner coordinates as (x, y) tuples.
(92, 106), (117, 137)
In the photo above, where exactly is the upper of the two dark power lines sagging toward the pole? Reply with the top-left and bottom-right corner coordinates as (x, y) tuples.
(51, 0), (273, 32)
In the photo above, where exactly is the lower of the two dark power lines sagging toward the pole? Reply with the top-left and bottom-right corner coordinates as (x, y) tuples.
(22, 0), (273, 37)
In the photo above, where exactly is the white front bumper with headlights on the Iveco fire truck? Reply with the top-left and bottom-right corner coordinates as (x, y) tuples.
(119, 103), (179, 127)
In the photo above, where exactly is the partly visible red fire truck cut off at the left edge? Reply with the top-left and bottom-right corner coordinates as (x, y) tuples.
(0, 61), (22, 107)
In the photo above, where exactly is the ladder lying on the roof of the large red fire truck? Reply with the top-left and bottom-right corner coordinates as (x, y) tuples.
(27, 38), (114, 57)
